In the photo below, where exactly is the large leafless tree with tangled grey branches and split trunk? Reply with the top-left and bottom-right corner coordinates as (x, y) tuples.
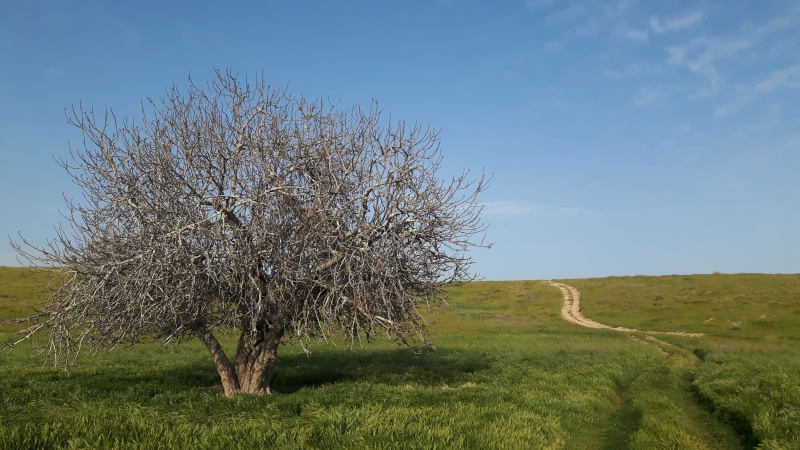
(12, 71), (487, 397)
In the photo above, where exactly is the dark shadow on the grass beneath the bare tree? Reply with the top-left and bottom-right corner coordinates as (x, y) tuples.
(0, 348), (491, 403)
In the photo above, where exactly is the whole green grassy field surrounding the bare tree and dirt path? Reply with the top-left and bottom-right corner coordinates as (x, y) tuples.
(0, 268), (800, 449)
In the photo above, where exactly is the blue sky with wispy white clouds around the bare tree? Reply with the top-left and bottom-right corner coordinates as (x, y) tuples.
(0, 0), (800, 280)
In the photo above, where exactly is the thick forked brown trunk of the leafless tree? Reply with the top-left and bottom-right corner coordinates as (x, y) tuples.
(194, 325), (284, 398)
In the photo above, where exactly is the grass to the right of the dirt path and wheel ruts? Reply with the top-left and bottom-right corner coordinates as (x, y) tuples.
(571, 274), (800, 449)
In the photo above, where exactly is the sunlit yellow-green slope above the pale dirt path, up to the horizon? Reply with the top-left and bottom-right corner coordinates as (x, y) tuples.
(571, 274), (800, 341)
